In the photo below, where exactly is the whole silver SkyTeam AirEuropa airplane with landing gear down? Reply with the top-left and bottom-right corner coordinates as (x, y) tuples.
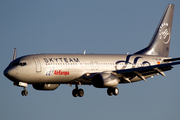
(4, 4), (180, 97)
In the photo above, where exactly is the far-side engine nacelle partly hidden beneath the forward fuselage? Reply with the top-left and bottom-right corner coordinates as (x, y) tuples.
(32, 84), (59, 90)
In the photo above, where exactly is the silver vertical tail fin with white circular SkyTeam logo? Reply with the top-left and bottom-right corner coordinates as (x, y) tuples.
(134, 4), (174, 57)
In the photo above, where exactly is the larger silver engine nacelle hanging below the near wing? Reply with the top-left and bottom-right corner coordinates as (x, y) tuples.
(92, 73), (120, 88)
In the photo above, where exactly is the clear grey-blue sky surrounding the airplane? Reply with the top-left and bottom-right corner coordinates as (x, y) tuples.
(0, 0), (180, 120)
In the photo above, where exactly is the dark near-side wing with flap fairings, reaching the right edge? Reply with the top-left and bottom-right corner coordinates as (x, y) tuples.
(69, 58), (180, 85)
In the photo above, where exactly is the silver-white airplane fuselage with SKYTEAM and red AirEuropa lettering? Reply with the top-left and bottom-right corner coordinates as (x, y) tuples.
(3, 54), (169, 84)
